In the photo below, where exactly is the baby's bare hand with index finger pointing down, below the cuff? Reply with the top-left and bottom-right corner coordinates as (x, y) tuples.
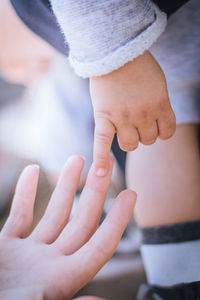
(90, 51), (176, 176)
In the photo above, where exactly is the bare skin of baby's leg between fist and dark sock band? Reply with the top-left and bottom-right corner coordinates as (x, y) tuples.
(126, 124), (200, 226)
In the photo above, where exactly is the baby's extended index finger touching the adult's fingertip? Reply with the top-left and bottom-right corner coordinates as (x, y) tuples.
(93, 118), (115, 177)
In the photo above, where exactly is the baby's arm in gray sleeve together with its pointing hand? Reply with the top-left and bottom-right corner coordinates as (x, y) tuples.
(51, 0), (175, 176)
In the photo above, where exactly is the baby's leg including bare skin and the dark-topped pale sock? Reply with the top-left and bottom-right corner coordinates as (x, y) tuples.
(126, 124), (200, 300)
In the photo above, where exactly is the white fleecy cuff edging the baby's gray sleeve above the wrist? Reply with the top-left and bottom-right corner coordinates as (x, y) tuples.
(69, 4), (167, 78)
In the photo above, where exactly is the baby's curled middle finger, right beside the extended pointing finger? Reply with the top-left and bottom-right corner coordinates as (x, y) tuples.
(117, 126), (139, 152)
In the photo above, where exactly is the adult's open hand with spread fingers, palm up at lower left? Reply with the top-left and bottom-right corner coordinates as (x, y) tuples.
(0, 156), (136, 300)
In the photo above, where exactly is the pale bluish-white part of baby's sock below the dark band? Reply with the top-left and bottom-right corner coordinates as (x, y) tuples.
(141, 240), (200, 286)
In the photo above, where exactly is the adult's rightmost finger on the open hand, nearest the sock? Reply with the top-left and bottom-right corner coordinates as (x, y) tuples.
(66, 190), (136, 285)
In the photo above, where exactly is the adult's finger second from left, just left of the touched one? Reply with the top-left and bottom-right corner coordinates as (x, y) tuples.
(31, 156), (84, 244)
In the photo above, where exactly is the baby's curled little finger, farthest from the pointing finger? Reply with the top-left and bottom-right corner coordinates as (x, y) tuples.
(157, 107), (176, 140)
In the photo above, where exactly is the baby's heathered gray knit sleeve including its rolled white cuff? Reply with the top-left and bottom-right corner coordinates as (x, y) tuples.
(51, 0), (166, 77)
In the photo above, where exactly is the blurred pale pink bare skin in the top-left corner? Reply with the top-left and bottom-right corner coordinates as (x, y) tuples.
(0, 0), (55, 84)
